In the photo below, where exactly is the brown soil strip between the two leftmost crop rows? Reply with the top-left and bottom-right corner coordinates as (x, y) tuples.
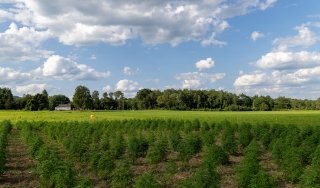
(0, 129), (39, 187)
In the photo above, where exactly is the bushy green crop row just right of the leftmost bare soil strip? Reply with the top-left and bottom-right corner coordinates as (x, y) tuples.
(17, 122), (91, 188)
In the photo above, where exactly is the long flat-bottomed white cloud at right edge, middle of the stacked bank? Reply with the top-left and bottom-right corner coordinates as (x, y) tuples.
(256, 51), (320, 69)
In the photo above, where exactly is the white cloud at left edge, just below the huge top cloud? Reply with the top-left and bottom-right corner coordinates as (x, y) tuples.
(0, 23), (52, 62)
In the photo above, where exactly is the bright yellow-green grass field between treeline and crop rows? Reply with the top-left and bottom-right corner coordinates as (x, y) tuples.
(0, 110), (320, 125)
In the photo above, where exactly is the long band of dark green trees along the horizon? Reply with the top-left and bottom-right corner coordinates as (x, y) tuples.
(0, 86), (320, 111)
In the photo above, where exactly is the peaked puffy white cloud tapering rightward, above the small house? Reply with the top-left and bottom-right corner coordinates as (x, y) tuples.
(34, 55), (110, 80)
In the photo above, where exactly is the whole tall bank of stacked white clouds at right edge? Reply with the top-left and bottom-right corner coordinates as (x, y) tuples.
(233, 22), (320, 98)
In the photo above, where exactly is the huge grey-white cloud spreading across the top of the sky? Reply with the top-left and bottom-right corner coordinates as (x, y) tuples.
(0, 0), (276, 45)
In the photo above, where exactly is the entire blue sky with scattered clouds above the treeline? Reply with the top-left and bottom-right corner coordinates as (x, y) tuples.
(0, 0), (320, 99)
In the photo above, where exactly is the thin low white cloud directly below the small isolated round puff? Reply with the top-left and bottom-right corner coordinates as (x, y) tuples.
(176, 72), (226, 89)
